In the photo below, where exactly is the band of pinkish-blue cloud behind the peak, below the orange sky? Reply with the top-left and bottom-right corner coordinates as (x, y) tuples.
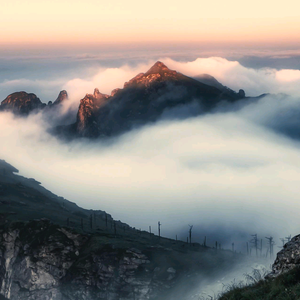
(0, 52), (300, 106)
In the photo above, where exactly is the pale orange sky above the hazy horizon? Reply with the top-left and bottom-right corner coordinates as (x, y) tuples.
(0, 0), (300, 47)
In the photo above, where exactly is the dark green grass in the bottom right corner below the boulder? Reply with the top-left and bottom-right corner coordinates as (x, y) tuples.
(219, 267), (300, 300)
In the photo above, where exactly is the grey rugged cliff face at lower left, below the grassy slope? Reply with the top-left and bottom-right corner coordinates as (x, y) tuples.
(0, 220), (196, 300)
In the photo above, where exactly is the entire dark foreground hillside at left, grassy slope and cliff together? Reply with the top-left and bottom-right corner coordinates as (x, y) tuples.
(0, 161), (248, 300)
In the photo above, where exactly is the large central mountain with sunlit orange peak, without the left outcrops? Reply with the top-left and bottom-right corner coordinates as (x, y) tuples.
(55, 61), (245, 138)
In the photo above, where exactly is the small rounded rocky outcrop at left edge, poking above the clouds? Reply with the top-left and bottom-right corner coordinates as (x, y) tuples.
(0, 92), (45, 115)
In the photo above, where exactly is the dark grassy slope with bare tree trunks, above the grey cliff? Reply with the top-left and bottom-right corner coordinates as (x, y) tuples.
(0, 164), (251, 299)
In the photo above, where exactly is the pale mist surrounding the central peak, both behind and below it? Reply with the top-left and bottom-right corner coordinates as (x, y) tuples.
(0, 57), (300, 252)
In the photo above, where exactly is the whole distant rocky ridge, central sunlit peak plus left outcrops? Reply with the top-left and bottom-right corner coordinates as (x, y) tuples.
(0, 61), (251, 139)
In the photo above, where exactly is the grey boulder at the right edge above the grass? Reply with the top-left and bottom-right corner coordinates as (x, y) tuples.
(269, 235), (300, 277)
